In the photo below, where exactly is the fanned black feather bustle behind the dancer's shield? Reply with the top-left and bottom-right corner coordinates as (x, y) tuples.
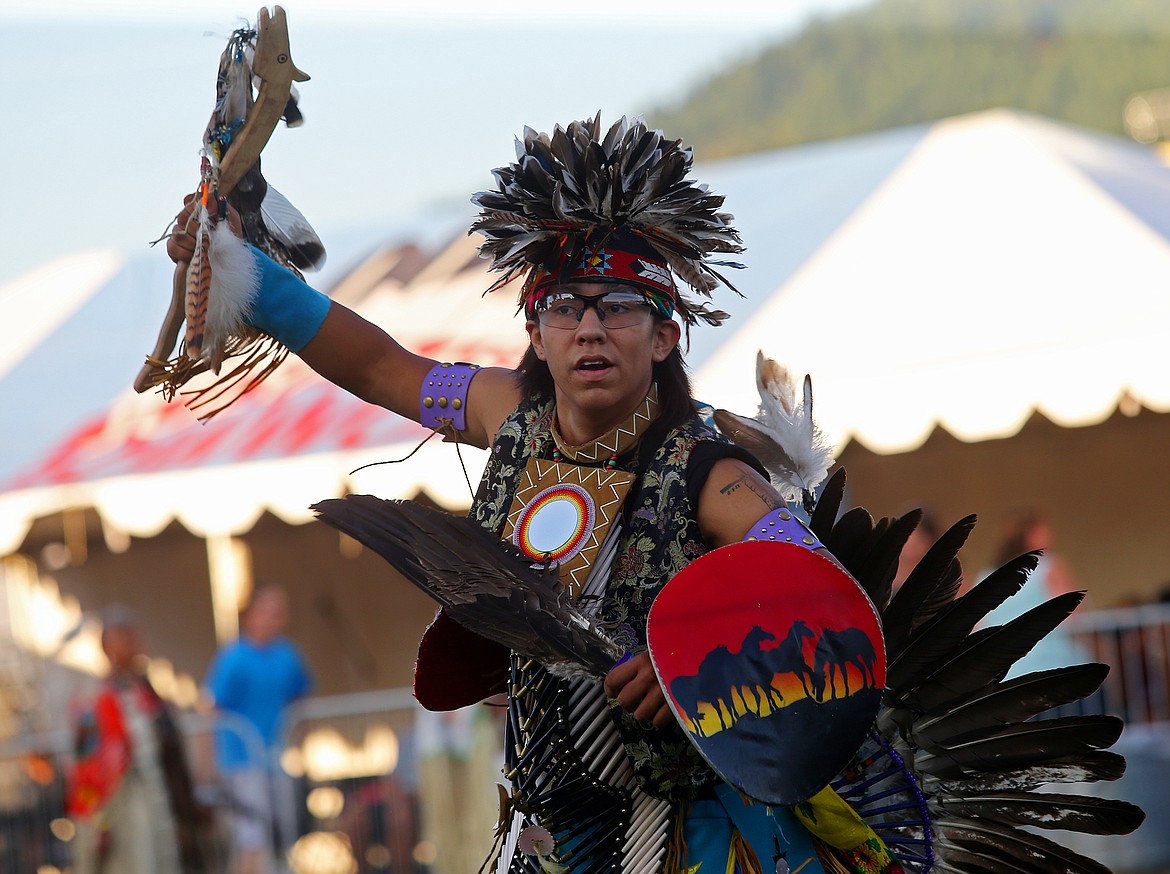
(811, 479), (1144, 874)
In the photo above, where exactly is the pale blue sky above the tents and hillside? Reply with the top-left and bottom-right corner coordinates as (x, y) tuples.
(0, 0), (866, 284)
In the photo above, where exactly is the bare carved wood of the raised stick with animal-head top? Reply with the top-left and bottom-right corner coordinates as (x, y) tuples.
(135, 6), (309, 393)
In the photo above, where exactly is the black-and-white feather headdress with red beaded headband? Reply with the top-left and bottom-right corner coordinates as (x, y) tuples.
(470, 113), (743, 328)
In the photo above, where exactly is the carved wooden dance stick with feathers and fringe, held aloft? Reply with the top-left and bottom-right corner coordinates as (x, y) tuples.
(135, 6), (324, 418)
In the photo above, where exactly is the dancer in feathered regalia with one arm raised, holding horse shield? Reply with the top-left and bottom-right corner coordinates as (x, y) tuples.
(168, 118), (1142, 874)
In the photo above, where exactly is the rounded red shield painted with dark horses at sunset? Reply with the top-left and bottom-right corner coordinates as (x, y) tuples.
(647, 542), (886, 804)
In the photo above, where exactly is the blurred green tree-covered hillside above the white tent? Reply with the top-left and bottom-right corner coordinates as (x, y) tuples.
(649, 0), (1170, 159)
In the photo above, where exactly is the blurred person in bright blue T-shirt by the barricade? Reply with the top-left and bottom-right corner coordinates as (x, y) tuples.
(205, 586), (312, 874)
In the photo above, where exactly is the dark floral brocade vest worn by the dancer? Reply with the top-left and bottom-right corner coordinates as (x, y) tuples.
(469, 398), (735, 800)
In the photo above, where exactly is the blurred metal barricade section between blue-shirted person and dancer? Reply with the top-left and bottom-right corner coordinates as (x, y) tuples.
(281, 688), (503, 874)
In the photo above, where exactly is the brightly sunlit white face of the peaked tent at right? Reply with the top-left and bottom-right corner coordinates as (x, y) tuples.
(697, 111), (1170, 453)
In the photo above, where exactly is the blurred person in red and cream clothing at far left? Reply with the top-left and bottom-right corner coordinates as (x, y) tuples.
(67, 605), (204, 874)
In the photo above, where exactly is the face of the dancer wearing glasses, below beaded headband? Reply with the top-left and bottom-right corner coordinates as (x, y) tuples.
(527, 282), (681, 428)
